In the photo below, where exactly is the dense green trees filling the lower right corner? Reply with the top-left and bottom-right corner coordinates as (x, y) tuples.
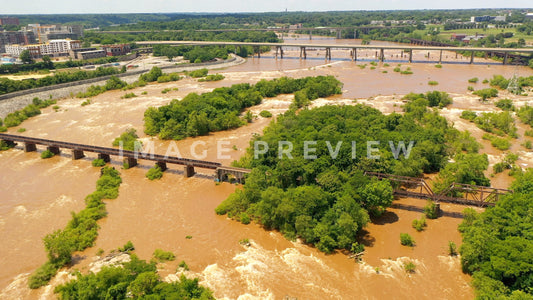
(459, 169), (533, 299)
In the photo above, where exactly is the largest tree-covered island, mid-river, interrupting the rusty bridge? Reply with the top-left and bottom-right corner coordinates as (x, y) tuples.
(216, 98), (462, 253)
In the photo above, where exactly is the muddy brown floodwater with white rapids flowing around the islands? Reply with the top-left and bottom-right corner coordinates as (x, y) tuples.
(0, 39), (532, 299)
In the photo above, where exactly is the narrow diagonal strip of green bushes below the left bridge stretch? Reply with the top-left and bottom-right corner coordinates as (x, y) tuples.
(28, 167), (122, 289)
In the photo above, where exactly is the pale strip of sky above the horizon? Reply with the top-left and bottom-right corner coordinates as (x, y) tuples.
(0, 0), (533, 15)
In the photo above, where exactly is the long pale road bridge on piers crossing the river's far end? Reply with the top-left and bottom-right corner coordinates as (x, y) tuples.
(136, 41), (533, 65)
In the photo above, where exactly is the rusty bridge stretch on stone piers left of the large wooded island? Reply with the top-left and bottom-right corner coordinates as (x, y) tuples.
(0, 133), (250, 182)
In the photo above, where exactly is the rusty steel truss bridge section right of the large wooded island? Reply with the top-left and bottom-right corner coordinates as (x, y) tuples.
(365, 172), (512, 207)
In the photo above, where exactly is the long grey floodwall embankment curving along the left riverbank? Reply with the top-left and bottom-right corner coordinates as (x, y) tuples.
(0, 57), (238, 118)
